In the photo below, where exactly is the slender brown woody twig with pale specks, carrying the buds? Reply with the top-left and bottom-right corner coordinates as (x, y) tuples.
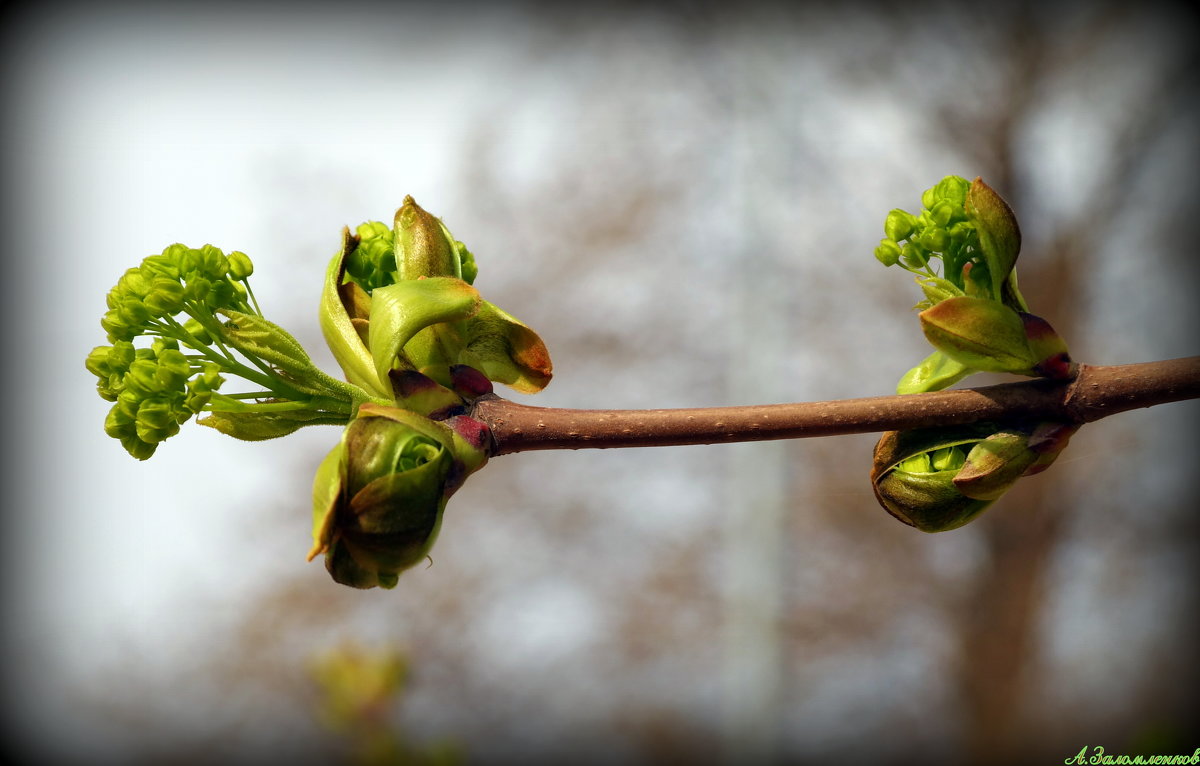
(472, 357), (1200, 455)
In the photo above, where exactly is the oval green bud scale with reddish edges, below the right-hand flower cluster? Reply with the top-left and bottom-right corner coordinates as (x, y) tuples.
(918, 295), (1038, 375)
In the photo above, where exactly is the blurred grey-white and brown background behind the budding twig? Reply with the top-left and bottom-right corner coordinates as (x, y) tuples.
(2, 1), (1200, 764)
